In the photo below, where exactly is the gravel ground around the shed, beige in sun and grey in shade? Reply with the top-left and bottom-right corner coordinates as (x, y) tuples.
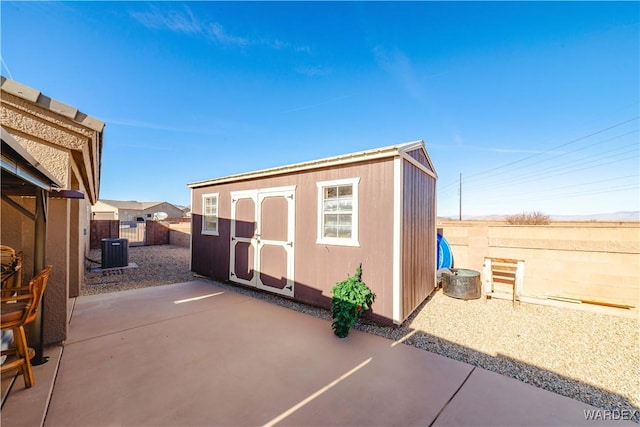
(81, 245), (640, 423)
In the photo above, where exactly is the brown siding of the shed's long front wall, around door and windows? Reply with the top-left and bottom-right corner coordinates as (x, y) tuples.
(192, 158), (394, 319)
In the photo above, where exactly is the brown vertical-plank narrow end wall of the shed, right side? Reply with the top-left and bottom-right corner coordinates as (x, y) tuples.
(401, 160), (437, 320)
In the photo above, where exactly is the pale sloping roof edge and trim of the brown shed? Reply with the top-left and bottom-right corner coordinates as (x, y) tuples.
(187, 140), (435, 188)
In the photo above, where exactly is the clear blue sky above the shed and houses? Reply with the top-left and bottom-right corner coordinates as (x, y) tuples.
(0, 0), (640, 217)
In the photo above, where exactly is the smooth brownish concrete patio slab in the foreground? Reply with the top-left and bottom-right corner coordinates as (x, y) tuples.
(2, 280), (633, 427)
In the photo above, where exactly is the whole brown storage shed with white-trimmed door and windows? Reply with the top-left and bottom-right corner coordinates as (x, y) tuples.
(188, 141), (437, 324)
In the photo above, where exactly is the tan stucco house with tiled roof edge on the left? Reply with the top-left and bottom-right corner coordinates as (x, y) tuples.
(0, 77), (104, 345)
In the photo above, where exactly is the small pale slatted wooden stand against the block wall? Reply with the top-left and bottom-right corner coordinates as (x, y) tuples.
(483, 257), (524, 307)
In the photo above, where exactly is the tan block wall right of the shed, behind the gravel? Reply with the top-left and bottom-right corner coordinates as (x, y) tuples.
(438, 221), (640, 307)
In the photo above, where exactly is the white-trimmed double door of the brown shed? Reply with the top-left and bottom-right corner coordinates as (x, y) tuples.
(229, 187), (295, 296)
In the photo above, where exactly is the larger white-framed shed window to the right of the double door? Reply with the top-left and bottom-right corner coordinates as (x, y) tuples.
(317, 178), (360, 246)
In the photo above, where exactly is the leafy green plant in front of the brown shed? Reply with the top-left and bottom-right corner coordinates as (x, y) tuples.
(331, 264), (376, 338)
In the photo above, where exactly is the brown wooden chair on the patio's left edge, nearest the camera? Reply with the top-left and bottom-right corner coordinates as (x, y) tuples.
(0, 266), (51, 388)
